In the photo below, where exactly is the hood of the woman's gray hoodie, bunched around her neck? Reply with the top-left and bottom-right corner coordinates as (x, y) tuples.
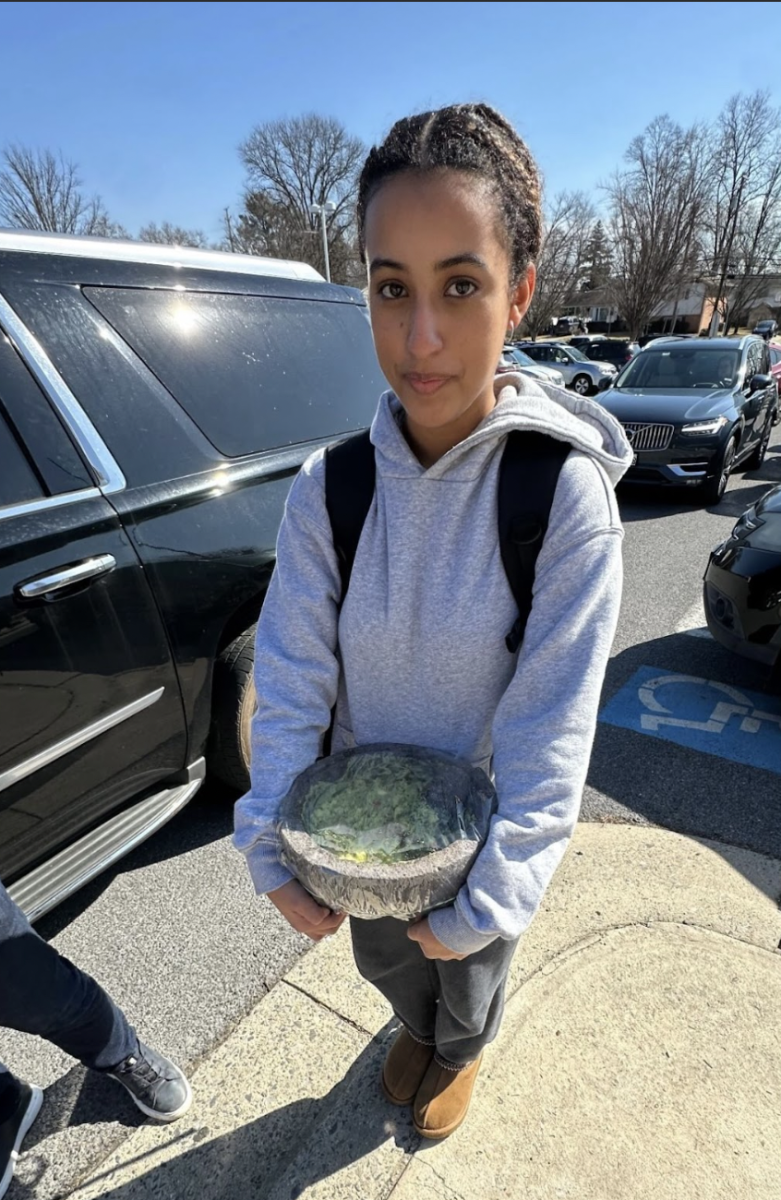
(371, 373), (632, 487)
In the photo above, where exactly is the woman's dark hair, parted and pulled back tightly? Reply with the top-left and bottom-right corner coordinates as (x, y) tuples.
(358, 104), (542, 283)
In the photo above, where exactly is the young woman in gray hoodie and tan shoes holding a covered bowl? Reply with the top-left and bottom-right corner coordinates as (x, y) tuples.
(230, 104), (631, 1139)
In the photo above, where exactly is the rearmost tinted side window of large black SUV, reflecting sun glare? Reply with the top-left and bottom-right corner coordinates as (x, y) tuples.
(84, 287), (383, 458)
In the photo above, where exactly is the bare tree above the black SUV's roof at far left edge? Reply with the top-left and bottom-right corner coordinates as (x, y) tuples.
(0, 145), (119, 238)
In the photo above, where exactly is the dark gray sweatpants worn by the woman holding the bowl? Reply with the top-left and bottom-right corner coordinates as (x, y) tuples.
(350, 917), (518, 1067)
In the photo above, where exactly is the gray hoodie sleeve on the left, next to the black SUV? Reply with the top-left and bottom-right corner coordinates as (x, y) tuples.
(233, 451), (341, 894)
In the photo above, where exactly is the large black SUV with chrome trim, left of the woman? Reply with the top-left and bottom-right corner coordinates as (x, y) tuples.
(0, 233), (383, 917)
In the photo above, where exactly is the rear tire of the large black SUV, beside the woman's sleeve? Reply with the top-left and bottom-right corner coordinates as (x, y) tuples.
(206, 625), (257, 792)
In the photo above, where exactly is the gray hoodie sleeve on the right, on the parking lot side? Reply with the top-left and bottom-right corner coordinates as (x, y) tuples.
(429, 454), (623, 954)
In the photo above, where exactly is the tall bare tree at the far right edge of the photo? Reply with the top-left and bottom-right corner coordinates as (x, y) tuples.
(704, 91), (781, 333)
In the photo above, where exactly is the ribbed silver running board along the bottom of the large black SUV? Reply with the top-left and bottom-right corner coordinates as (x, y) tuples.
(8, 779), (203, 920)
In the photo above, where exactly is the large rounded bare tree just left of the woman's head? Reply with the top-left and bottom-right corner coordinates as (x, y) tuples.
(233, 113), (366, 282)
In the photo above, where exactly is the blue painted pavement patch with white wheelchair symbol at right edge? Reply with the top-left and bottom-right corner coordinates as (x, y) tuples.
(600, 667), (781, 775)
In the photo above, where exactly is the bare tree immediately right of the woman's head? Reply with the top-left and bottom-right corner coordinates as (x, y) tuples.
(524, 192), (594, 337)
